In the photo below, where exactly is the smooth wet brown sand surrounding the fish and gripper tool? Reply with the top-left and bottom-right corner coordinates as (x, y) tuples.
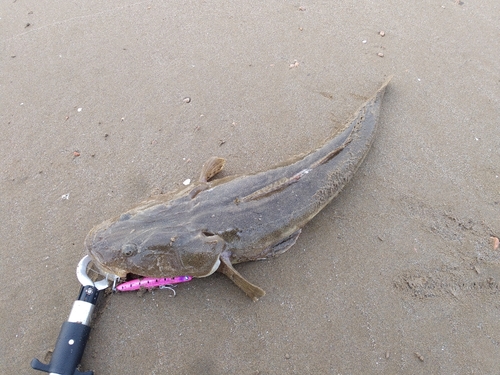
(0, 0), (500, 375)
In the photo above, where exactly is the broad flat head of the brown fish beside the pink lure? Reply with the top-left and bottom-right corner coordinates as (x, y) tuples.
(85, 204), (226, 278)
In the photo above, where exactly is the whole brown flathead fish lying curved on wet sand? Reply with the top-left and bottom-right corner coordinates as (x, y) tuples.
(84, 78), (390, 301)
